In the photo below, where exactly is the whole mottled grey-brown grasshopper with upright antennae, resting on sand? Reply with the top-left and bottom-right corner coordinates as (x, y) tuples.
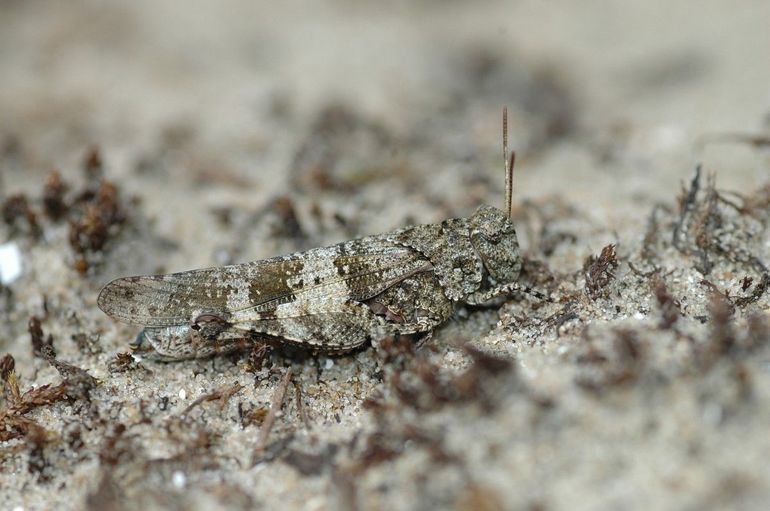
(98, 110), (525, 360)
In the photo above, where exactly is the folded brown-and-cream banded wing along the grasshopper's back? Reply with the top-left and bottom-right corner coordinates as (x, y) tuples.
(97, 237), (431, 327)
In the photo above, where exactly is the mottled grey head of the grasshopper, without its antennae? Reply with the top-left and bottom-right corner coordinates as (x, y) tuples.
(470, 206), (521, 285)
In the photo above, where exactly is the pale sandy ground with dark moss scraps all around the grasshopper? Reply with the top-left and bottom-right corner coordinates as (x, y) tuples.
(0, 0), (770, 510)
